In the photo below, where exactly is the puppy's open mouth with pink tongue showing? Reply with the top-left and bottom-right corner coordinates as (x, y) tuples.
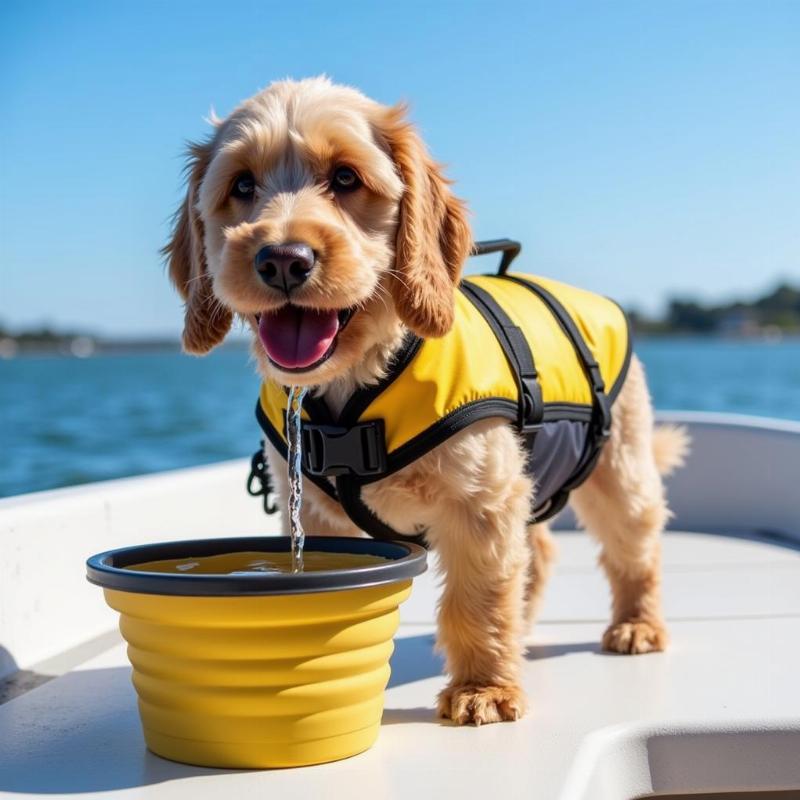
(258, 305), (339, 369)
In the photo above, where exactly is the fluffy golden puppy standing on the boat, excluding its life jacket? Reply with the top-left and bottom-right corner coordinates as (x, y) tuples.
(164, 77), (688, 725)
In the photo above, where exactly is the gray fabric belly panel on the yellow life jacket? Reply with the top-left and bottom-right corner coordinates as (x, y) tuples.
(526, 419), (589, 509)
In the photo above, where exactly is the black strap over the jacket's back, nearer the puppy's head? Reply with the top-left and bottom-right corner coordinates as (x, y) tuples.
(461, 281), (544, 434)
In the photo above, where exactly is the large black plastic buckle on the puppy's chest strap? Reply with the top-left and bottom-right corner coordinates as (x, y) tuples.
(302, 419), (386, 477)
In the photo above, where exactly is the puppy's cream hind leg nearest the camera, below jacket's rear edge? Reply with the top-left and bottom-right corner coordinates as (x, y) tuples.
(572, 358), (669, 653)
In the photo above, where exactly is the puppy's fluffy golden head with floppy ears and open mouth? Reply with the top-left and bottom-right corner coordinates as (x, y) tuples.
(165, 78), (471, 385)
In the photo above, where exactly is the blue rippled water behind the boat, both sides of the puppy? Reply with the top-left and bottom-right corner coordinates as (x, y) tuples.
(0, 339), (800, 497)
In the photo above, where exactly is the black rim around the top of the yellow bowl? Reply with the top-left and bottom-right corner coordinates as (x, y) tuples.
(86, 536), (427, 597)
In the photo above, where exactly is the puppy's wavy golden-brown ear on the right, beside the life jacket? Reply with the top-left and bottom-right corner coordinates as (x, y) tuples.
(378, 105), (472, 337)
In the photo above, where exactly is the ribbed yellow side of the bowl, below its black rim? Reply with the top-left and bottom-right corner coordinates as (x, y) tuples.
(105, 581), (411, 768)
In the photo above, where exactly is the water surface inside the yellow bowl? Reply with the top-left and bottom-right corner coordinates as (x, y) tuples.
(126, 550), (386, 575)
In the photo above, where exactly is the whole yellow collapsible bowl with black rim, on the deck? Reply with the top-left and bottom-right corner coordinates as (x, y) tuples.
(87, 536), (426, 768)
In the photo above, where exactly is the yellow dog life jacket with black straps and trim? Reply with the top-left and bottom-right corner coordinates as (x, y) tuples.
(254, 266), (630, 540)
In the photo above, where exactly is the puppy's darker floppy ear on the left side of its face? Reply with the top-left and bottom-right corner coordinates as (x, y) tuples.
(162, 139), (233, 355)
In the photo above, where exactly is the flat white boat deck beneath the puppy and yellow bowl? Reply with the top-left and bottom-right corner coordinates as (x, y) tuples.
(0, 416), (800, 800)
